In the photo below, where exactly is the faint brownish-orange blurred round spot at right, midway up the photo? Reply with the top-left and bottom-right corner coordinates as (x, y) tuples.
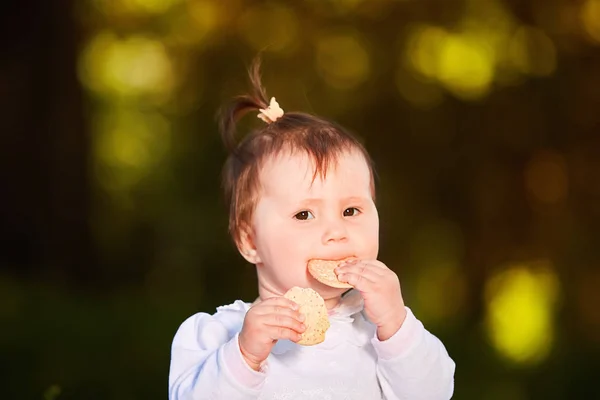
(525, 151), (569, 204)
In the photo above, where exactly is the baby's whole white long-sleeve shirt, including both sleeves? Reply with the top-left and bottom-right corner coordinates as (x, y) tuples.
(169, 290), (455, 400)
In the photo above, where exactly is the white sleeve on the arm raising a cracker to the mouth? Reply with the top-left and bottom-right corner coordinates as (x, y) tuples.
(371, 307), (456, 400)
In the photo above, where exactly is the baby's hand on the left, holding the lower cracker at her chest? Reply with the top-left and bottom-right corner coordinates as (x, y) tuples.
(239, 297), (306, 371)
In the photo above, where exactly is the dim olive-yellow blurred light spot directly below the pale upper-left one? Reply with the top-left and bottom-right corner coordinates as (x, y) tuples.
(93, 110), (171, 191)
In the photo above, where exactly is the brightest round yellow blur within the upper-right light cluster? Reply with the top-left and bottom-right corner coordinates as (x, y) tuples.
(438, 34), (495, 100)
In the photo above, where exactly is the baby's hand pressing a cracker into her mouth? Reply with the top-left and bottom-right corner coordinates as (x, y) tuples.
(335, 260), (406, 341)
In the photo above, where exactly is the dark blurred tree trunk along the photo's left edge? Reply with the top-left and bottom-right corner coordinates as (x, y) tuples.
(0, 0), (94, 281)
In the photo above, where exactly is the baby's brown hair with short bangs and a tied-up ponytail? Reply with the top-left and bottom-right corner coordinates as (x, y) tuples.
(219, 58), (375, 246)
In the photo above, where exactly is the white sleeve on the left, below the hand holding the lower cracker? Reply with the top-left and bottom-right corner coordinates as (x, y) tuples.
(169, 313), (266, 400)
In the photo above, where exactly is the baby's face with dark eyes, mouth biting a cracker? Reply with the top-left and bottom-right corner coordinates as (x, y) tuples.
(253, 151), (379, 299)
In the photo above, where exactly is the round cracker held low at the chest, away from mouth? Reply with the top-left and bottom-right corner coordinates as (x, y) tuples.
(283, 286), (330, 346)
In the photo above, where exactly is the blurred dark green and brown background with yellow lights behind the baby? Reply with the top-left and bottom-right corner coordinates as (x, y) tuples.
(0, 0), (600, 400)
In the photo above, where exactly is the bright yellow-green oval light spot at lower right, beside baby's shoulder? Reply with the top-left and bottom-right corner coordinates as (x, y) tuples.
(485, 262), (559, 365)
